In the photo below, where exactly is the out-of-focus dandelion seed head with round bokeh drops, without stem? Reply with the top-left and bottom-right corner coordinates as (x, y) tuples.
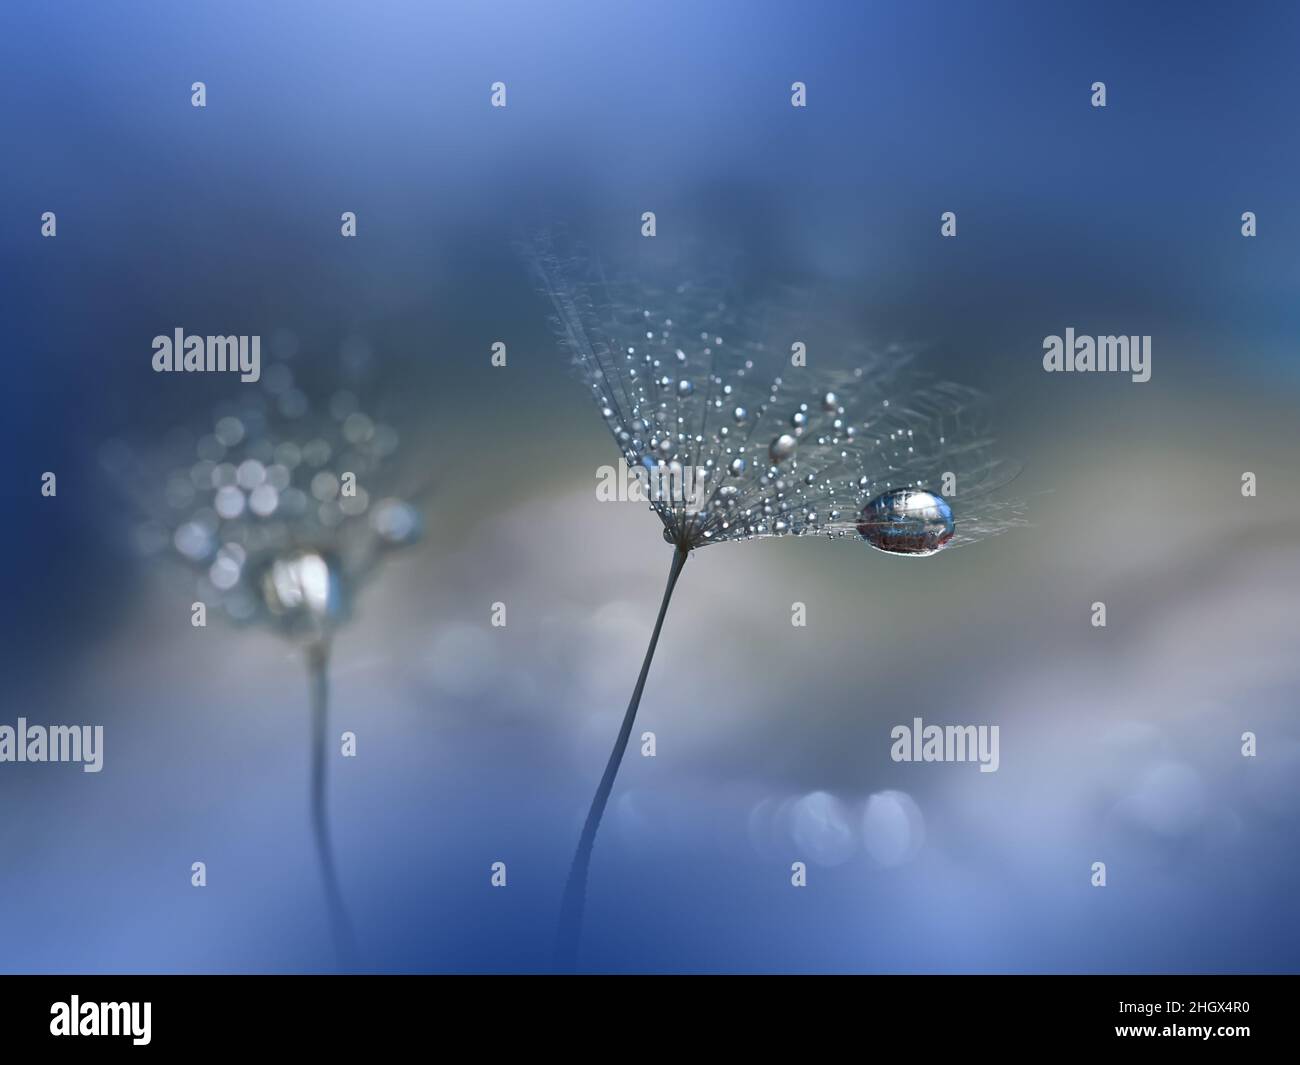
(101, 362), (421, 642)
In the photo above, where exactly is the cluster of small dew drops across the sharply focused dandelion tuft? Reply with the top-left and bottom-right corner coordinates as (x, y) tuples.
(589, 300), (944, 546)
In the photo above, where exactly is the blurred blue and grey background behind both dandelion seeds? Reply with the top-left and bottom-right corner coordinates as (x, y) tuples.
(0, 0), (1300, 973)
